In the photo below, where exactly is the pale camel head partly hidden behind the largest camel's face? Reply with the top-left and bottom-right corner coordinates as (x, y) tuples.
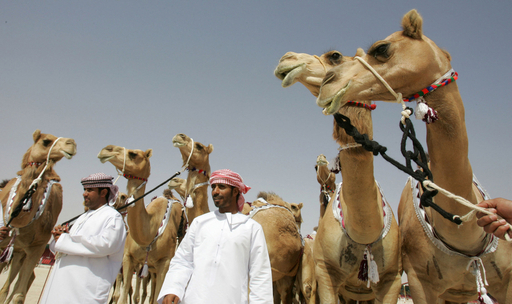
(274, 51), (345, 97)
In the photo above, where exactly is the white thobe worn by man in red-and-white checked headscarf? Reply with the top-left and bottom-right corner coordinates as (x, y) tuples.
(158, 210), (273, 304)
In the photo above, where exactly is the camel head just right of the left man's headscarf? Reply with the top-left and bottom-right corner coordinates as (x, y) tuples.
(98, 145), (153, 179)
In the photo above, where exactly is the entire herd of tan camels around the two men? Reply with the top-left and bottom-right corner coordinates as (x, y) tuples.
(0, 10), (512, 303)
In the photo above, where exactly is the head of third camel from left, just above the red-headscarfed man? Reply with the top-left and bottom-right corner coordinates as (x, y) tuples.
(172, 133), (213, 176)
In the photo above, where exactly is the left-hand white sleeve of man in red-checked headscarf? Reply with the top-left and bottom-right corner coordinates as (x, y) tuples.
(158, 220), (197, 304)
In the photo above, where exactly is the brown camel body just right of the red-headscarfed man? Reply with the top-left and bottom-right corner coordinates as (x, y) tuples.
(249, 192), (302, 304)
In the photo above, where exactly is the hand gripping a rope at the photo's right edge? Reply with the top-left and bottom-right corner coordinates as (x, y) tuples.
(476, 198), (512, 240)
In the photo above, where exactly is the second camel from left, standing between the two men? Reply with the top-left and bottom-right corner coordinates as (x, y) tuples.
(98, 145), (182, 303)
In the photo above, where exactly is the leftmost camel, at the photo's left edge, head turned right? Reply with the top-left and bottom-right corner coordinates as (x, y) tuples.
(0, 130), (76, 303)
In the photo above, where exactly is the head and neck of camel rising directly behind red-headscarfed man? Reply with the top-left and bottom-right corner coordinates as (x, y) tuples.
(172, 133), (213, 225)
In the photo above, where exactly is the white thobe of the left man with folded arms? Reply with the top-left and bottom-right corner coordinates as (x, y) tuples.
(40, 205), (126, 304)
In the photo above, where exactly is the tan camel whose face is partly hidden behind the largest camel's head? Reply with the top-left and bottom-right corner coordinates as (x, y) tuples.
(275, 51), (402, 303)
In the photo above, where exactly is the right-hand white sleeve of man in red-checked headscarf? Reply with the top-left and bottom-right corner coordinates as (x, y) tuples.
(249, 225), (274, 304)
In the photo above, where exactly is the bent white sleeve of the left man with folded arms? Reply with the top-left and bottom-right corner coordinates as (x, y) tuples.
(55, 216), (126, 257)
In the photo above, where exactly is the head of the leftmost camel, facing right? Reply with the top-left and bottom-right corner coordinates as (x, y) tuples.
(21, 130), (76, 169)
